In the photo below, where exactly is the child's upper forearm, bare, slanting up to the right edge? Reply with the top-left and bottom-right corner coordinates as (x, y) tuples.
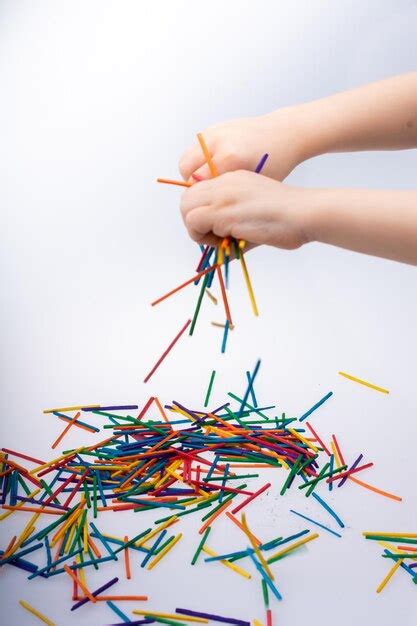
(267, 72), (417, 161)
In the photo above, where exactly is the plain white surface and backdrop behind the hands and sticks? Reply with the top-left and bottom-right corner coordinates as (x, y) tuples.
(0, 0), (417, 626)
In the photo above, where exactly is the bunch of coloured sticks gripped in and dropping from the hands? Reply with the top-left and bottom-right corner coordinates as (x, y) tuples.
(150, 133), (268, 382)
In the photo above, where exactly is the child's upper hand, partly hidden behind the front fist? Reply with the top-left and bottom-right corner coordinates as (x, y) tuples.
(179, 107), (310, 180)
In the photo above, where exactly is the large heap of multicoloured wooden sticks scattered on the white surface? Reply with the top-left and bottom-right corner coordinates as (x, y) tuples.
(0, 362), (410, 626)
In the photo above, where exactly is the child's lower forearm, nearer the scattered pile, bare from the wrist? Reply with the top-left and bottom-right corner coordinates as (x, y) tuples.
(305, 189), (417, 265)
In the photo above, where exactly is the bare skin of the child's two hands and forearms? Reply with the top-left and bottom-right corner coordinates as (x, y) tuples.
(180, 72), (417, 265)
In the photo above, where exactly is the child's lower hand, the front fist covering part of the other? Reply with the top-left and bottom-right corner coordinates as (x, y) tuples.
(181, 170), (313, 250)
